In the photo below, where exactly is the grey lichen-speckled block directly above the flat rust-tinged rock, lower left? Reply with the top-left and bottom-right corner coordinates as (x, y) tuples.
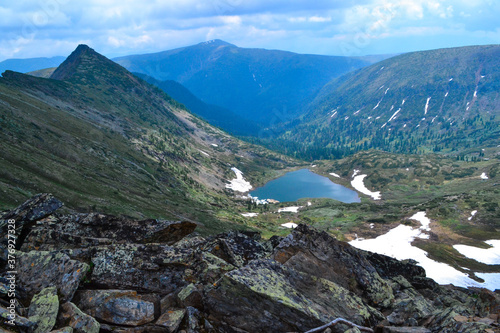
(91, 244), (195, 294)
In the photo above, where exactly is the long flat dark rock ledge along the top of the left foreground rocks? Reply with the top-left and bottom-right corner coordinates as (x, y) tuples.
(21, 213), (197, 250)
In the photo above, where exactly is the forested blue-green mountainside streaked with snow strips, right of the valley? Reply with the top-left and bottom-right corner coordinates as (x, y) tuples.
(271, 45), (500, 158)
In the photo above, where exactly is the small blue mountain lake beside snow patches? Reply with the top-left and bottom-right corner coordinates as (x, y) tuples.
(250, 169), (360, 203)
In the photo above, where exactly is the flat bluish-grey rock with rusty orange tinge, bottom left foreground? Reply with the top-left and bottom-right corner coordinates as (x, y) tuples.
(75, 290), (155, 326)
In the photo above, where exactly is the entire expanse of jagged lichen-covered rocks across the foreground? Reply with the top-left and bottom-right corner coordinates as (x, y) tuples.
(0, 194), (500, 333)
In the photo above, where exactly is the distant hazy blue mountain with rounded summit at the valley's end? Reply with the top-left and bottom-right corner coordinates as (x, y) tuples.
(114, 40), (368, 124)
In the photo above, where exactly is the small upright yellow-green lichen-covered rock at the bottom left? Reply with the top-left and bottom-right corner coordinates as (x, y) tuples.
(28, 287), (59, 333)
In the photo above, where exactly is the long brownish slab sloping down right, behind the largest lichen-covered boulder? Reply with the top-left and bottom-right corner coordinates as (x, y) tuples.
(272, 224), (394, 307)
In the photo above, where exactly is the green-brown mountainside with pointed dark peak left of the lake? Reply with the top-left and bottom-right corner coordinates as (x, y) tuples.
(0, 45), (294, 232)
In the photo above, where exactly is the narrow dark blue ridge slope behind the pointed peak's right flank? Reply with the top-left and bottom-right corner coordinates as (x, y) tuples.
(135, 73), (261, 136)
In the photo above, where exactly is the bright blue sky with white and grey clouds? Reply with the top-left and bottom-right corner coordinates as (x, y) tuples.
(0, 0), (500, 61)
